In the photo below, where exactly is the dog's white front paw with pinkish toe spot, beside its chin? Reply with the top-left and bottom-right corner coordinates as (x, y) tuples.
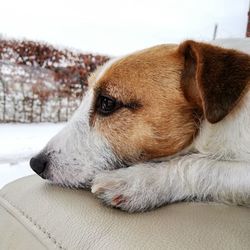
(91, 167), (161, 212)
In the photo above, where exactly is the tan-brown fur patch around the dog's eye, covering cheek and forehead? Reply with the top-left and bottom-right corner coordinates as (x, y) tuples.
(91, 45), (197, 162)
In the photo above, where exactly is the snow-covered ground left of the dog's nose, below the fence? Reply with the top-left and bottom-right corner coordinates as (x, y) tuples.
(0, 123), (64, 188)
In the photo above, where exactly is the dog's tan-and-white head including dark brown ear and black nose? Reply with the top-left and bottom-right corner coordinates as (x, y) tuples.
(30, 41), (250, 187)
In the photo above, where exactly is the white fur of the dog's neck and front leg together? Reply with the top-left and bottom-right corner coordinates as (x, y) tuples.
(92, 93), (250, 212)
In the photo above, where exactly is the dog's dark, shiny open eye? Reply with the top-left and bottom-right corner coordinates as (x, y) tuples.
(97, 95), (120, 115)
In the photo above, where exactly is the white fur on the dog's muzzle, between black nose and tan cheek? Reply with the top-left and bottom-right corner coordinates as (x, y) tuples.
(42, 89), (116, 187)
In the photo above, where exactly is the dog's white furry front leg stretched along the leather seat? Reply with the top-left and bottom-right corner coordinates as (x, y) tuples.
(92, 154), (250, 212)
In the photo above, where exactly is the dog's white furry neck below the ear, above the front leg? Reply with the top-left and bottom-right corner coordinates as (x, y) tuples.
(193, 91), (250, 161)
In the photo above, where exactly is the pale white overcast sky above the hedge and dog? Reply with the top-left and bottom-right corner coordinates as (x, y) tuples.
(0, 0), (249, 55)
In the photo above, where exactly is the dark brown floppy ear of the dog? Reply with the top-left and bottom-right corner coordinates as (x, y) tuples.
(179, 41), (250, 123)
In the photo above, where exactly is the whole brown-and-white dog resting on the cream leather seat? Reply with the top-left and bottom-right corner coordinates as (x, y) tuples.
(30, 40), (250, 212)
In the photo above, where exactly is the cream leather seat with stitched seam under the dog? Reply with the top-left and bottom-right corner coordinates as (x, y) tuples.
(0, 176), (250, 250)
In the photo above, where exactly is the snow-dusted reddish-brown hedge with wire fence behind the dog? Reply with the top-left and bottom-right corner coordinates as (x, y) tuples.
(0, 40), (108, 123)
